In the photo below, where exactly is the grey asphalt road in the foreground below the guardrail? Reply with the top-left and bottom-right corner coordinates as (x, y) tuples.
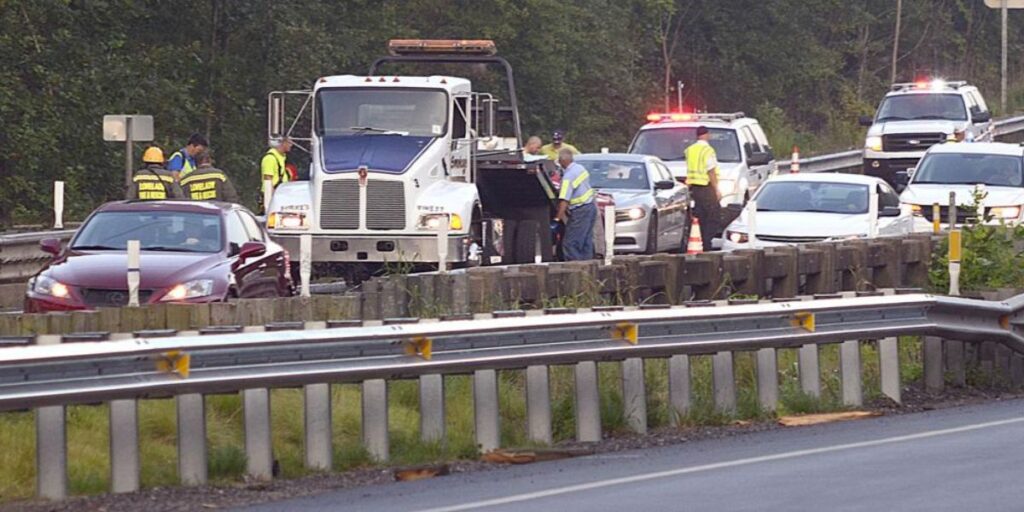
(245, 400), (1024, 512)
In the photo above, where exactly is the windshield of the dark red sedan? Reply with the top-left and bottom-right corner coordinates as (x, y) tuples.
(72, 211), (223, 253)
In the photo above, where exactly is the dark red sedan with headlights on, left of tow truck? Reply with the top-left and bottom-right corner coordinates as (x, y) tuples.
(25, 201), (295, 312)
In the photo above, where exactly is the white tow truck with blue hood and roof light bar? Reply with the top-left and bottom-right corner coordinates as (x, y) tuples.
(260, 40), (555, 282)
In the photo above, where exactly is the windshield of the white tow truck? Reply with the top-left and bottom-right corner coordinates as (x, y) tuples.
(316, 88), (447, 137)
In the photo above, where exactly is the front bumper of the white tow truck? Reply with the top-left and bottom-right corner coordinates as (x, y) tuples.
(270, 233), (469, 263)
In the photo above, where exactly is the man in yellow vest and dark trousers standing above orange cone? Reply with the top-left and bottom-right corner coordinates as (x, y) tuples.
(686, 126), (722, 251)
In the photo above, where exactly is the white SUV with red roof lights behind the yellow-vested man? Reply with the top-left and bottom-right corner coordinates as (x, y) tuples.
(629, 112), (775, 206)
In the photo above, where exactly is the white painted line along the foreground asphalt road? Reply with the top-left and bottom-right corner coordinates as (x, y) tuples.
(411, 417), (1024, 512)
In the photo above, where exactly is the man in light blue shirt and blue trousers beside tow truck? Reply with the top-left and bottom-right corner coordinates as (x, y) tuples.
(555, 147), (597, 261)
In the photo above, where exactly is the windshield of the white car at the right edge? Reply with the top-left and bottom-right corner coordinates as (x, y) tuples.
(913, 153), (1024, 186)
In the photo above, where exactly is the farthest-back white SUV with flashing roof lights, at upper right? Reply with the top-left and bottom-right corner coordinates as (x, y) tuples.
(860, 80), (991, 189)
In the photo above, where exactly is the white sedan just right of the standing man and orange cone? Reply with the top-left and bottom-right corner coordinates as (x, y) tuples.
(721, 174), (913, 251)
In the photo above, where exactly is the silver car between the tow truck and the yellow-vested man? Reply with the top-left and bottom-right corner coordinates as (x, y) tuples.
(575, 153), (690, 254)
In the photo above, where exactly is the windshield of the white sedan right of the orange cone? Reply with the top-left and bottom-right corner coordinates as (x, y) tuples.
(754, 181), (867, 214)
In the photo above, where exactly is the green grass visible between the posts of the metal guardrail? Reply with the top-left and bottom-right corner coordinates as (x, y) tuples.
(0, 338), (937, 501)
